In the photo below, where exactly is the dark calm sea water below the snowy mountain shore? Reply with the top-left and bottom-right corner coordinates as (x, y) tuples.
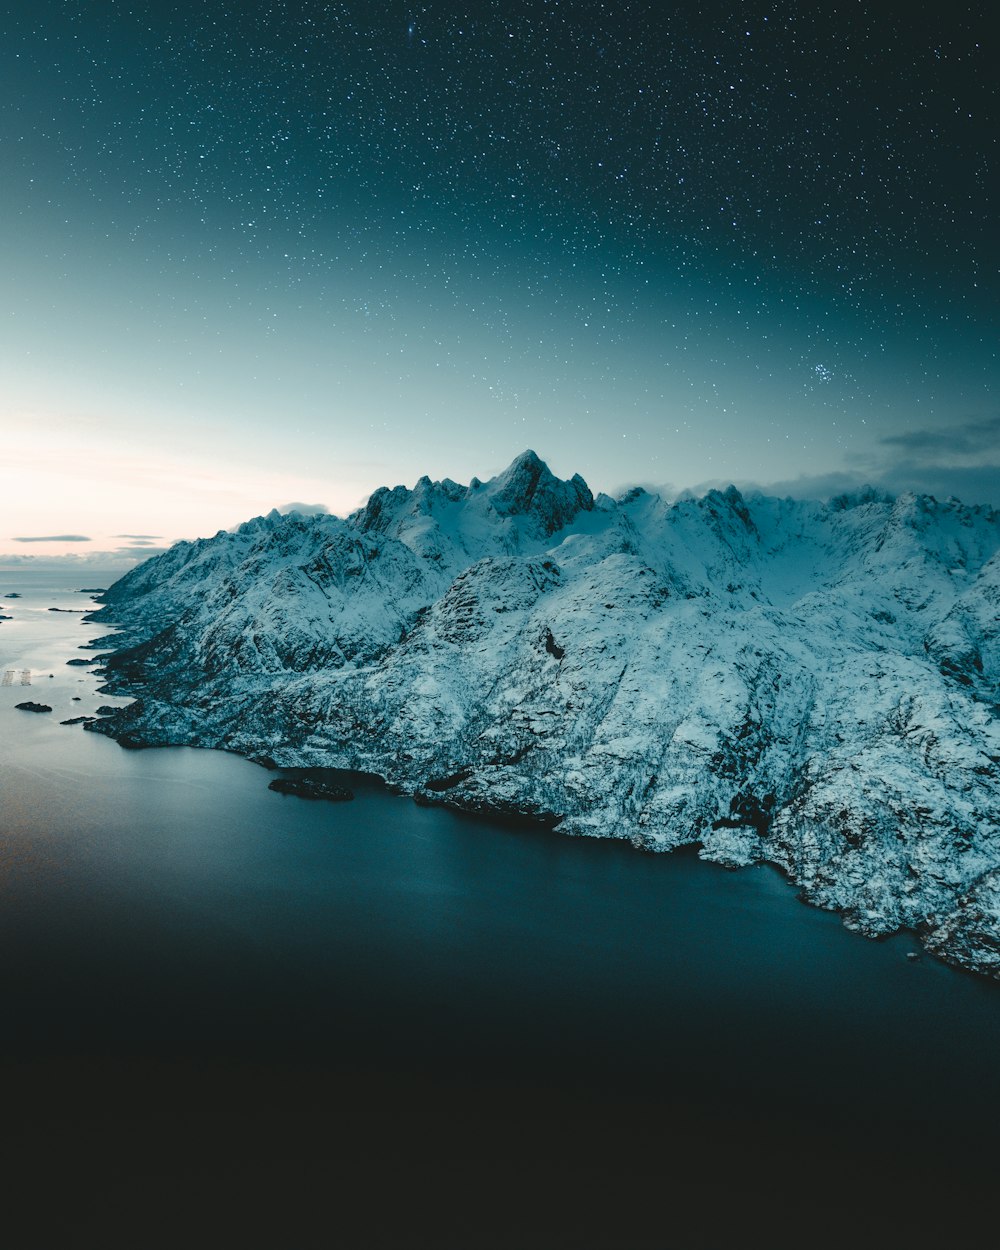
(0, 573), (1000, 1248)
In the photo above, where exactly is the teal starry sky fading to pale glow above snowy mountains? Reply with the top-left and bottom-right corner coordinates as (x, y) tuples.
(0, 0), (1000, 559)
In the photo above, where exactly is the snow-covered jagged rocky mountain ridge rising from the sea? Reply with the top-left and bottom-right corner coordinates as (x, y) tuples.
(88, 453), (1000, 976)
